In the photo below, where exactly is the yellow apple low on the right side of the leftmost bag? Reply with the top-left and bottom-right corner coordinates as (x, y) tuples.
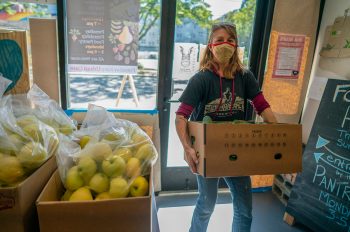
(18, 142), (47, 170)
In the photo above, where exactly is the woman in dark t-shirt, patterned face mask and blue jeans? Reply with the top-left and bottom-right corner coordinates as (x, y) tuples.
(175, 23), (276, 232)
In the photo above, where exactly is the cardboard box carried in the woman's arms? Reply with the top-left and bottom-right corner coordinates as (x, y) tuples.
(189, 122), (302, 177)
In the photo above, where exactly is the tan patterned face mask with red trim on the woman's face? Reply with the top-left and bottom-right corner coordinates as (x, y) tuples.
(208, 42), (237, 64)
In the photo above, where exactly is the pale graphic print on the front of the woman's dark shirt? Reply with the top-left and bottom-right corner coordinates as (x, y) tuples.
(204, 88), (244, 117)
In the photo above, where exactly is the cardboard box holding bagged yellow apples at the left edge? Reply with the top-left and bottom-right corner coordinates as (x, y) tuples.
(0, 85), (75, 231)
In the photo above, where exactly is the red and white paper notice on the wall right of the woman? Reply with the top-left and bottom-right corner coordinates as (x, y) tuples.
(272, 34), (305, 79)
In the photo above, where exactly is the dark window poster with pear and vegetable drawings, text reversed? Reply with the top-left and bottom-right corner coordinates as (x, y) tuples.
(66, 0), (140, 75)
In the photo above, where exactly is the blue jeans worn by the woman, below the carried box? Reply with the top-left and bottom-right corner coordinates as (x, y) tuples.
(190, 175), (252, 232)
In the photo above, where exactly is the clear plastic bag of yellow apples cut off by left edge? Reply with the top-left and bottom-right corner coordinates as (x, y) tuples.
(0, 101), (59, 187)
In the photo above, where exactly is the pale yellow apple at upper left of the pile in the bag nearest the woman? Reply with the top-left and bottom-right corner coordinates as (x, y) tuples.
(81, 142), (112, 162)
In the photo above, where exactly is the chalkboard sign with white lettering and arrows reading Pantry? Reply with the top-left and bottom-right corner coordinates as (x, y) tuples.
(286, 79), (350, 232)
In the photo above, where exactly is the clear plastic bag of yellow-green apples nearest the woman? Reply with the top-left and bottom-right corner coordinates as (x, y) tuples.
(57, 106), (158, 200)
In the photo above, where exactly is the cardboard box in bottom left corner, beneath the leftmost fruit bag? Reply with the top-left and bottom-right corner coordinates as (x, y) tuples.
(0, 156), (57, 232)
